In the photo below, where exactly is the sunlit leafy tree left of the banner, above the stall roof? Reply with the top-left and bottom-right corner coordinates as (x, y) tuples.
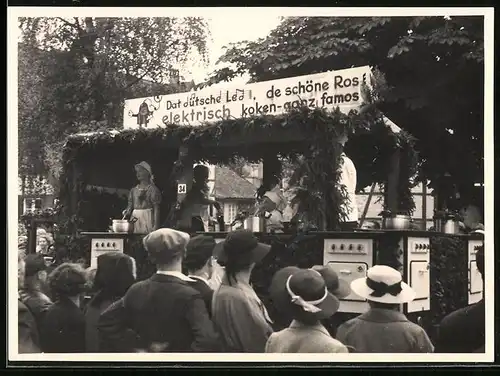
(18, 17), (209, 183)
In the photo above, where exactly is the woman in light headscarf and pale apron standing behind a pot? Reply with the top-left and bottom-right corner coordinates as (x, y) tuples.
(123, 161), (161, 234)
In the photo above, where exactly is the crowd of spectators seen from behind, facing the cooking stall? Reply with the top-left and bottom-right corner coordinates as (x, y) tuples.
(18, 228), (485, 353)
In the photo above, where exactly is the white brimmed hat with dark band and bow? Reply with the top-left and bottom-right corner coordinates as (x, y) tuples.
(351, 265), (415, 304)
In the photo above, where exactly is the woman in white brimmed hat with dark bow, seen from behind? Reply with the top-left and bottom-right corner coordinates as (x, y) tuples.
(337, 265), (434, 353)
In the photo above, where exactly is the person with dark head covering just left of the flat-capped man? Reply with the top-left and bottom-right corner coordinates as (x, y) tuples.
(85, 252), (136, 353)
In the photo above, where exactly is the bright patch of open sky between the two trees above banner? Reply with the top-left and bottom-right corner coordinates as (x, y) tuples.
(185, 13), (280, 83)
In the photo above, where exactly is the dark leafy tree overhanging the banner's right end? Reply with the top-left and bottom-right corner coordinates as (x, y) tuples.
(205, 17), (484, 204)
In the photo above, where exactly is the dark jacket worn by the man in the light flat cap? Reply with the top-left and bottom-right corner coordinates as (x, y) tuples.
(99, 274), (221, 352)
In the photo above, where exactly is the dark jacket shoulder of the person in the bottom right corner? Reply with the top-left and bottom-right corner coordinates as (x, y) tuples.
(435, 300), (485, 353)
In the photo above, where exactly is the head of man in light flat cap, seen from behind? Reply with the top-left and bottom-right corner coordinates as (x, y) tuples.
(146, 228), (189, 271)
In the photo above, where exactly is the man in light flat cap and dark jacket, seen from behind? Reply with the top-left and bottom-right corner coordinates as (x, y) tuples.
(99, 228), (220, 352)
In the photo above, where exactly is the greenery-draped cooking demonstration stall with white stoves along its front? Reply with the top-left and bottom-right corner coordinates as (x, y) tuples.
(55, 67), (482, 335)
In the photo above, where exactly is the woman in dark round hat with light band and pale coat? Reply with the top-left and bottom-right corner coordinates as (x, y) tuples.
(266, 266), (350, 353)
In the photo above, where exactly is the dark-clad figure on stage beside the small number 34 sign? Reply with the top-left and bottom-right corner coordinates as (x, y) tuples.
(177, 165), (222, 233)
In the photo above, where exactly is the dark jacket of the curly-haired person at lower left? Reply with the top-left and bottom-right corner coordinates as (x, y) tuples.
(40, 298), (85, 353)
